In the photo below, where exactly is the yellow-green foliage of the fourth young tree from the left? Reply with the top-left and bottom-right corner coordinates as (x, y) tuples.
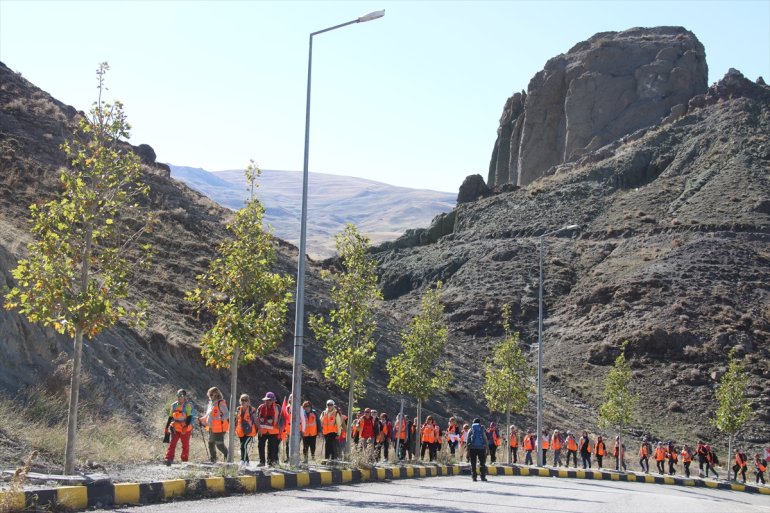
(386, 282), (452, 401)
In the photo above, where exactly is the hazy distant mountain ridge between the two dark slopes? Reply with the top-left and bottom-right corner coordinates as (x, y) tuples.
(170, 165), (456, 258)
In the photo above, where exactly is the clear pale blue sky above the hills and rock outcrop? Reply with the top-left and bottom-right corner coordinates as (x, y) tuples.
(0, 0), (770, 192)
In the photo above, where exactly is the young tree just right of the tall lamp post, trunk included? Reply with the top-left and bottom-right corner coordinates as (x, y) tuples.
(309, 223), (382, 452)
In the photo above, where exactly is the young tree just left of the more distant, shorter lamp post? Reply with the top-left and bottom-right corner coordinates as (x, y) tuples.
(482, 303), (540, 463)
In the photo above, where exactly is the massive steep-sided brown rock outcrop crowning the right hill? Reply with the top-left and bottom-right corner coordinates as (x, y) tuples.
(487, 27), (708, 187)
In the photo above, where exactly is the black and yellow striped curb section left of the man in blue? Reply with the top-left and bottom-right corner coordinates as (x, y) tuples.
(0, 465), (462, 511)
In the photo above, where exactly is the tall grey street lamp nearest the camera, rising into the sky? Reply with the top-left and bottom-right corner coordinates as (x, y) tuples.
(289, 10), (385, 467)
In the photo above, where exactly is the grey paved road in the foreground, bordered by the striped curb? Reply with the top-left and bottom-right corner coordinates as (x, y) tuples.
(100, 476), (770, 513)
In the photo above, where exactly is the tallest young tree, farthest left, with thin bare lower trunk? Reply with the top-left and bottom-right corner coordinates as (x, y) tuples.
(5, 62), (151, 475)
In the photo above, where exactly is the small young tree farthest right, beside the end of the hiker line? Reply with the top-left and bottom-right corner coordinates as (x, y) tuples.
(713, 351), (752, 461)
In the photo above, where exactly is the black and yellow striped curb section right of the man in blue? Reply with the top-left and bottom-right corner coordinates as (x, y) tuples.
(487, 464), (770, 495)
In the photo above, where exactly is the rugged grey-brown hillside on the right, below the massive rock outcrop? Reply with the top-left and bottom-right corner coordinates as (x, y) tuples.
(370, 62), (770, 445)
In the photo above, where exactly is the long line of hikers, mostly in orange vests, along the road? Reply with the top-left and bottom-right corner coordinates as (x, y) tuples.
(164, 387), (770, 484)
